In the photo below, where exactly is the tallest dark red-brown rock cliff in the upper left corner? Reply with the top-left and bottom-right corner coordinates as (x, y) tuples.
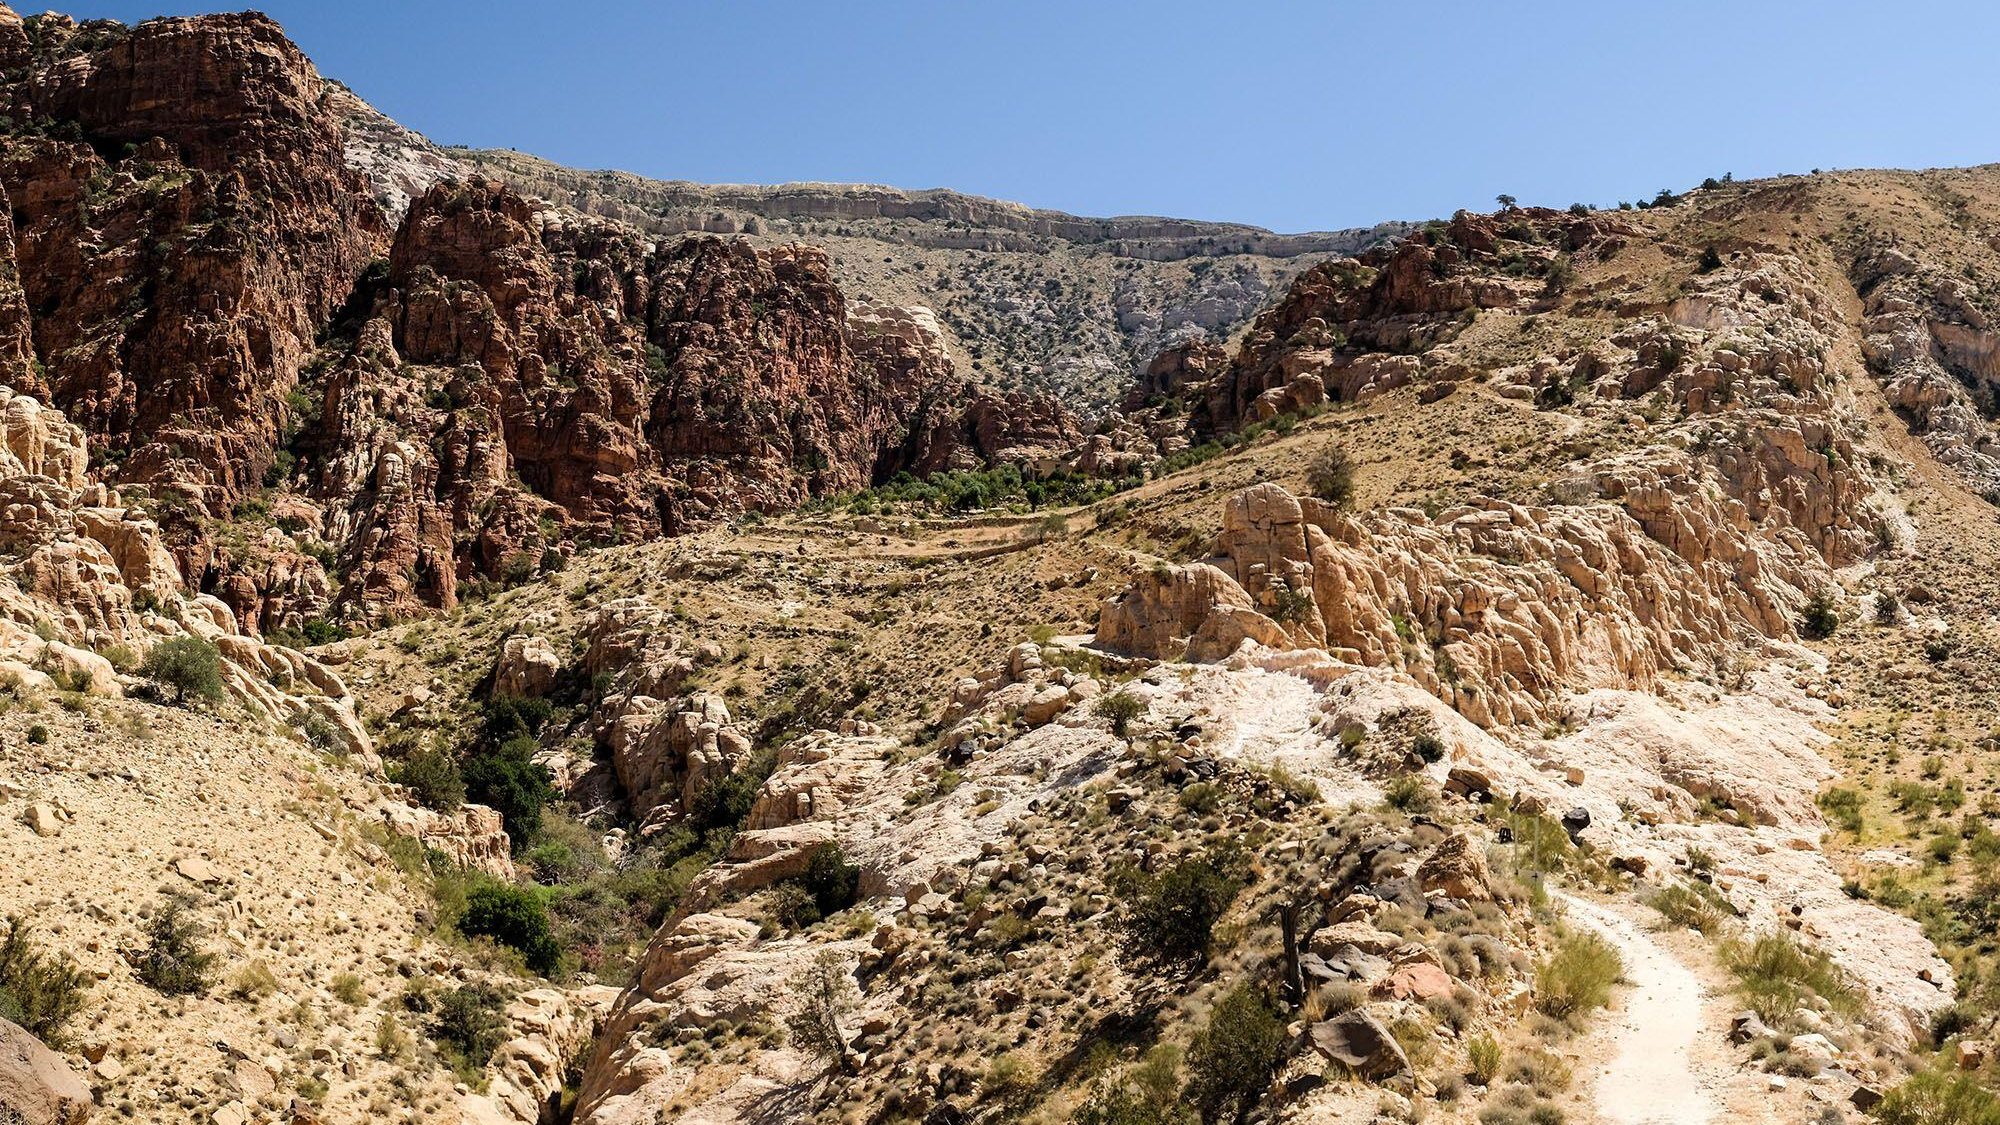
(0, 6), (386, 516)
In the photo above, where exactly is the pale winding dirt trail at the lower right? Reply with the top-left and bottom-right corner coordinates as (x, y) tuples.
(1556, 893), (1718, 1125)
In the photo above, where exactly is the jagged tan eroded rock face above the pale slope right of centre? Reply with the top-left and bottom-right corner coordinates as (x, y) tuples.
(1098, 474), (1808, 725)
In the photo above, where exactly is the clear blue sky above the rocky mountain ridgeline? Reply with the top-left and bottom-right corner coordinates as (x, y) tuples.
(62, 0), (2000, 230)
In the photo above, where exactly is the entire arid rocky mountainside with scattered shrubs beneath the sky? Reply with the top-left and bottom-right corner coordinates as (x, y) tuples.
(11, 10), (2000, 1125)
